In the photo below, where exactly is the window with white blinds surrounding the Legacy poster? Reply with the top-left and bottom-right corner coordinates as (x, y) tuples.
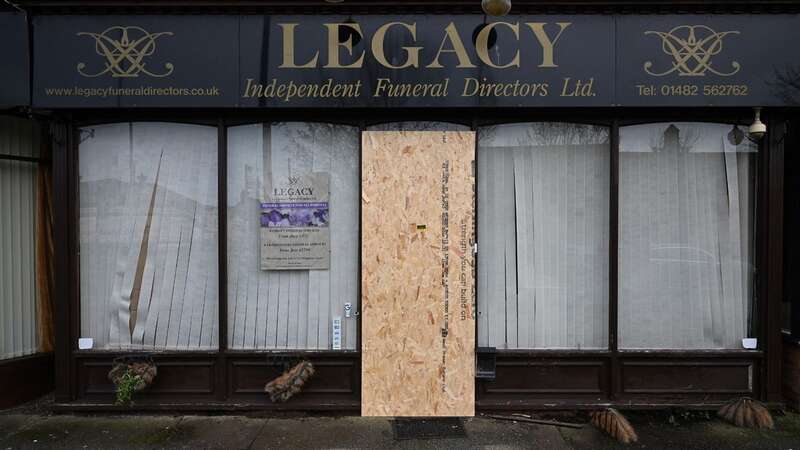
(228, 123), (360, 350)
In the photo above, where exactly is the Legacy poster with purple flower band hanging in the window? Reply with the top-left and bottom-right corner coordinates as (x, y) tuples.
(261, 172), (331, 270)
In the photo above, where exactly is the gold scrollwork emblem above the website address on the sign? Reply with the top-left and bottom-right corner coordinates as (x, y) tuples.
(78, 26), (175, 78)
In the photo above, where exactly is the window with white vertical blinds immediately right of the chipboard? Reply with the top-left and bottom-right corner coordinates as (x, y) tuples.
(478, 123), (610, 349)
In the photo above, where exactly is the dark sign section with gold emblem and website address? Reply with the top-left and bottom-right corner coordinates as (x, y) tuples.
(33, 15), (239, 108)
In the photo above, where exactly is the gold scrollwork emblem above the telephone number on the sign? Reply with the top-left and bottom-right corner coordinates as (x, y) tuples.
(644, 25), (742, 77)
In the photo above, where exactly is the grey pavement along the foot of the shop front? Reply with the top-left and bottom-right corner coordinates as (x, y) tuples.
(0, 411), (800, 450)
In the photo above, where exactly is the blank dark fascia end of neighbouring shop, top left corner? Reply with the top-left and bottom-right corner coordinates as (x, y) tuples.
(0, 13), (30, 109)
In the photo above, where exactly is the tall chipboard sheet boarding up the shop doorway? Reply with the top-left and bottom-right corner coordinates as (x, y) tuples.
(361, 131), (475, 417)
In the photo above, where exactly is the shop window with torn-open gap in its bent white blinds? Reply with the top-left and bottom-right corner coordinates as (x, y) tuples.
(79, 123), (219, 350)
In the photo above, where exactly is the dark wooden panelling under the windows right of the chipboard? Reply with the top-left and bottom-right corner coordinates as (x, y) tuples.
(478, 352), (762, 410)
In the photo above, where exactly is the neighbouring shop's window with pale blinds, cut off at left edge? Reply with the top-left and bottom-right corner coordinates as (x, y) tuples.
(0, 117), (45, 360)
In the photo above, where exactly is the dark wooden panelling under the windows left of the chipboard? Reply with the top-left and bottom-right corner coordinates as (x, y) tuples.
(65, 352), (361, 412)
